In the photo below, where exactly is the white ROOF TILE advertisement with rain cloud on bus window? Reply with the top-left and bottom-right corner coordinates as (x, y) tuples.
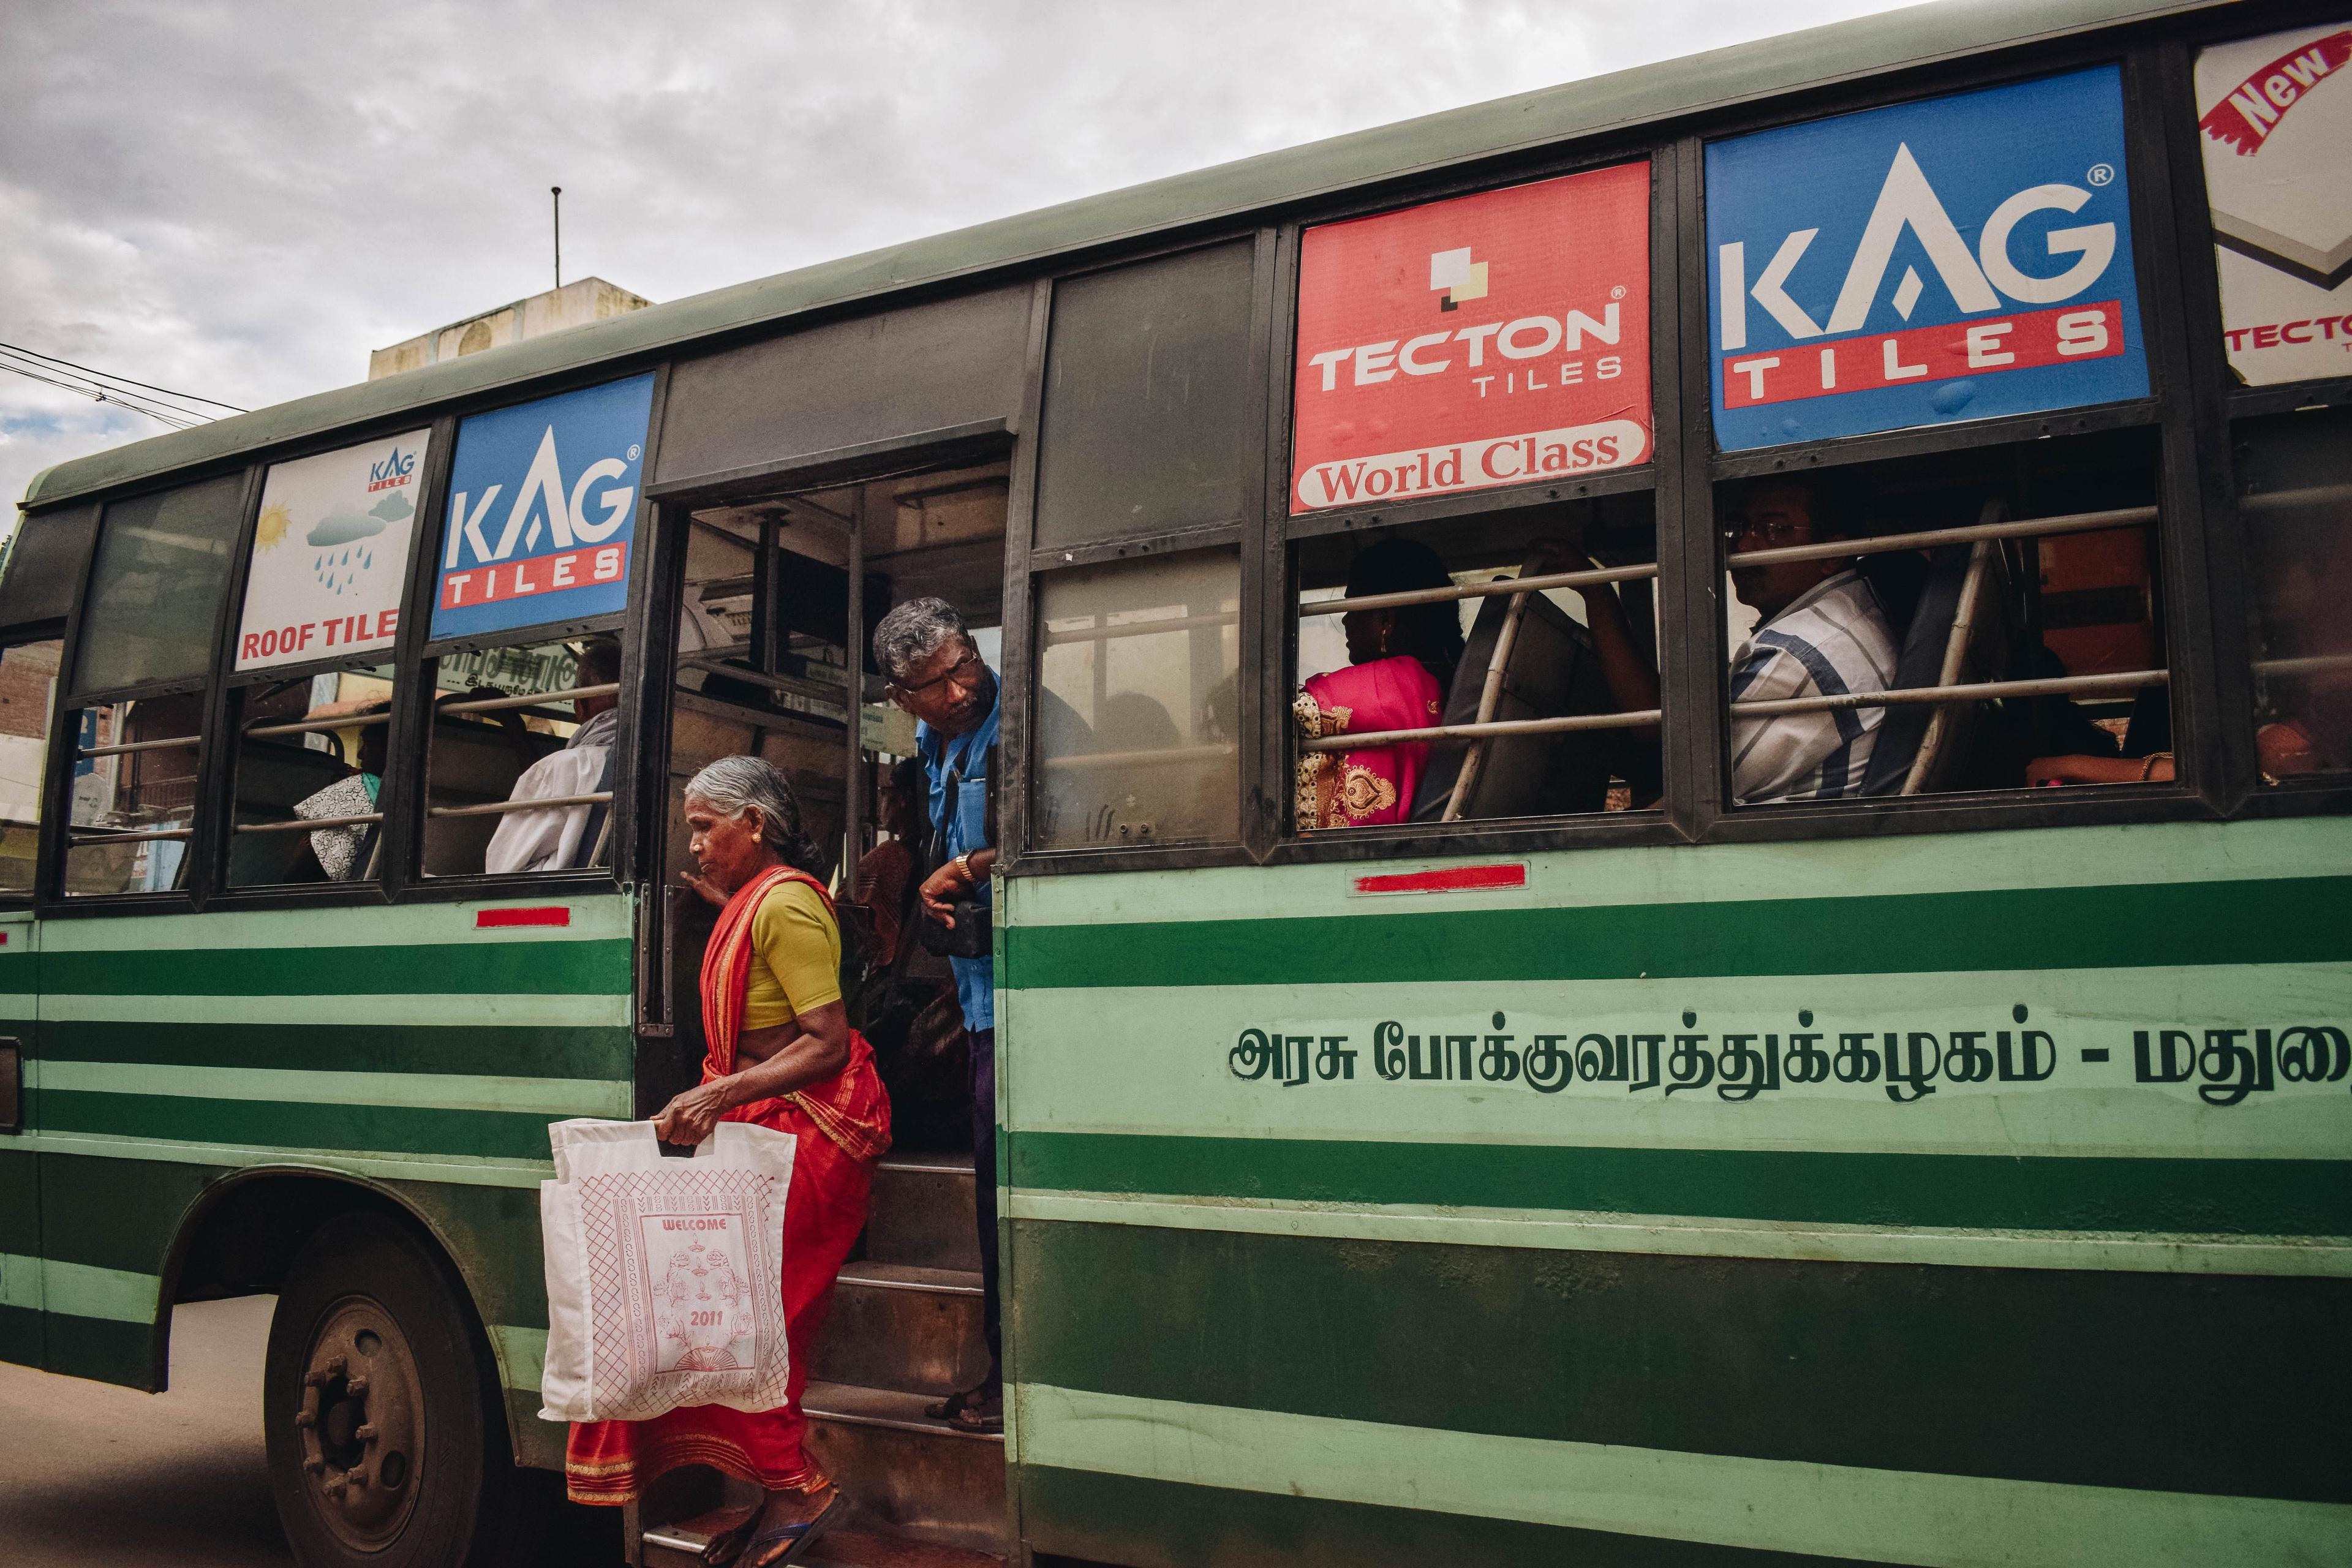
(238, 430), (428, 670)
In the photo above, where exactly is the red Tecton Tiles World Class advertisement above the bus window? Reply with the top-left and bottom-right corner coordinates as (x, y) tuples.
(1291, 162), (1651, 513)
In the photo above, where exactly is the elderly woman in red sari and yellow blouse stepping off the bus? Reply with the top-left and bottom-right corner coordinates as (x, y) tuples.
(567, 757), (889, 1568)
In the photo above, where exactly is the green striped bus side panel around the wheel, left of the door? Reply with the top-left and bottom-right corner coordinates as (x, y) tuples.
(16, 895), (635, 1429)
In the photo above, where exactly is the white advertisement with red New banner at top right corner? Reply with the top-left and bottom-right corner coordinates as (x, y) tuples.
(2197, 23), (2352, 385)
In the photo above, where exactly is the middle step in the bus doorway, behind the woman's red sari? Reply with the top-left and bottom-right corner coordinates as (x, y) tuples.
(809, 1262), (988, 1399)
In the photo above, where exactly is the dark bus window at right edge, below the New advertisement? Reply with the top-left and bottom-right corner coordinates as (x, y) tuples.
(2234, 409), (2352, 783)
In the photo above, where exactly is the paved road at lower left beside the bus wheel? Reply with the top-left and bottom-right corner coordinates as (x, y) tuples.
(0, 1298), (294, 1568)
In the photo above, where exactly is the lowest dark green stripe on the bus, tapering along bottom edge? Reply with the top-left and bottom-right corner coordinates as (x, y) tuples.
(1014, 1464), (1806, 1568)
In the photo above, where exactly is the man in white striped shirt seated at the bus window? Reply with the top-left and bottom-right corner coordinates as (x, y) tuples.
(1724, 480), (1896, 806)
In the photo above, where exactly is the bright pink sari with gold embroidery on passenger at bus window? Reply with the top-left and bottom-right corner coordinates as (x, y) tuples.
(1291, 654), (1444, 832)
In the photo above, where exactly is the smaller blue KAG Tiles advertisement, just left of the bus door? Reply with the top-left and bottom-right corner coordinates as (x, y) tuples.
(433, 376), (654, 639)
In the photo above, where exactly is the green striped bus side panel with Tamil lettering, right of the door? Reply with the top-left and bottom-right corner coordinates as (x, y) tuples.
(1000, 818), (2352, 1566)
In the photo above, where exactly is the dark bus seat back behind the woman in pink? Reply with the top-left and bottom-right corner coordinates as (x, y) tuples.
(1414, 573), (1613, 823)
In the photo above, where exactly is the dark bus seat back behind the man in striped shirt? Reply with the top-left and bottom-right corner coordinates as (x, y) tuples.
(1863, 501), (2016, 794)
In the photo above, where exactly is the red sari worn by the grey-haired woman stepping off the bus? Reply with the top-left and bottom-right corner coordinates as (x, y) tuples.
(565, 865), (889, 1504)
